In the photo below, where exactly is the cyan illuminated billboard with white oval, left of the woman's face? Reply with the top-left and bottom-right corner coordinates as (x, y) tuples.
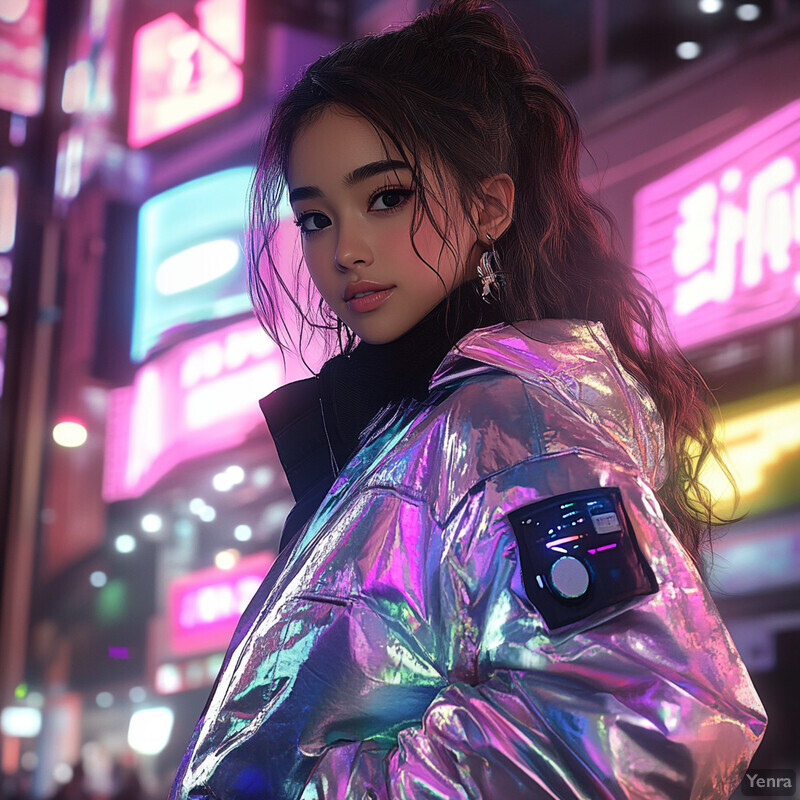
(131, 167), (252, 362)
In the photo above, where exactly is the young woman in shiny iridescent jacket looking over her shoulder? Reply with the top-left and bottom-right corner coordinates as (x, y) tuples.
(167, 0), (765, 800)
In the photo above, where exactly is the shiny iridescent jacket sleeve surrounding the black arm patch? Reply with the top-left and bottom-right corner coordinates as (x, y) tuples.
(302, 449), (766, 800)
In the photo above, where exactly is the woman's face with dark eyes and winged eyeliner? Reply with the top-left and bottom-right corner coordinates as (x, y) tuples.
(287, 105), (480, 344)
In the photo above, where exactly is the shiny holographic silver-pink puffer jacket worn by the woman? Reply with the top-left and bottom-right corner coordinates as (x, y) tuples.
(172, 320), (766, 800)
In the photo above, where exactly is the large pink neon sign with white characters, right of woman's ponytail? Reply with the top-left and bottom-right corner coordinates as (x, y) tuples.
(634, 101), (800, 347)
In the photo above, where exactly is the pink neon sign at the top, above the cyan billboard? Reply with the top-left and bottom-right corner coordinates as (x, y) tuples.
(128, 0), (245, 147)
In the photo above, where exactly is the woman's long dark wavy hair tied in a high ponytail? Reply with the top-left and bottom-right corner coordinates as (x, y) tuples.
(249, 0), (724, 570)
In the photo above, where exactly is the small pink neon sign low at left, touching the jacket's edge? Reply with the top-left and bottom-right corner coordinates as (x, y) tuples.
(168, 552), (275, 656)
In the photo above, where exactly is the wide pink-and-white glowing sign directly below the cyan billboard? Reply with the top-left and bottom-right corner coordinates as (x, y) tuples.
(103, 320), (321, 502)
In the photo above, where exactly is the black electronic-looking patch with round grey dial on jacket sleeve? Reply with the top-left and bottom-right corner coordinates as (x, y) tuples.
(508, 488), (658, 630)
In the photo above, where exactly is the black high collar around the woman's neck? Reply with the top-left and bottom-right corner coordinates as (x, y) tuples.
(261, 281), (502, 548)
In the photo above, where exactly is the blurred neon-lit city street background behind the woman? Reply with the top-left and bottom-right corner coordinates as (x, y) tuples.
(0, 0), (800, 798)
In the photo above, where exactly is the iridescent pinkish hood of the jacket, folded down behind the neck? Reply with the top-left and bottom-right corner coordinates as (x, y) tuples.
(430, 319), (667, 489)
